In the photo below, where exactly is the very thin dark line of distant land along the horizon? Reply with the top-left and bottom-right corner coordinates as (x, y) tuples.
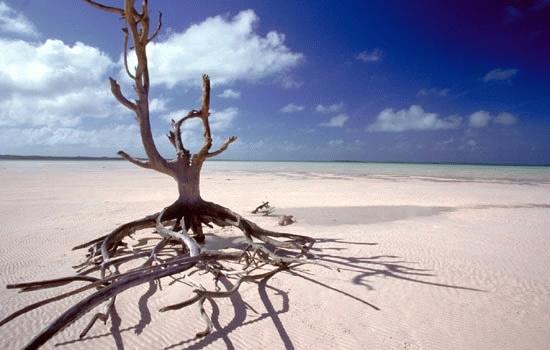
(0, 154), (550, 167)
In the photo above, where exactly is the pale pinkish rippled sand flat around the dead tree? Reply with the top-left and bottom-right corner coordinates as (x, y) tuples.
(0, 162), (550, 349)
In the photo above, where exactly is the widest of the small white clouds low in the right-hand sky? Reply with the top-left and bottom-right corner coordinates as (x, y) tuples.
(367, 105), (462, 132)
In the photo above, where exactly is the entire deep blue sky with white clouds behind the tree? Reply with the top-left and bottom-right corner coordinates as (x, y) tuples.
(0, 0), (550, 164)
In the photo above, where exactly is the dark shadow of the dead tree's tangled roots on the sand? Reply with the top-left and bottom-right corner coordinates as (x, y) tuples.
(56, 230), (483, 349)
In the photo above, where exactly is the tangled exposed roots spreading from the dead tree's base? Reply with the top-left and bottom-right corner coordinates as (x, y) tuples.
(0, 200), (320, 349)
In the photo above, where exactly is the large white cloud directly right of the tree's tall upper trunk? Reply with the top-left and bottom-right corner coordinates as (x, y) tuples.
(129, 10), (303, 88)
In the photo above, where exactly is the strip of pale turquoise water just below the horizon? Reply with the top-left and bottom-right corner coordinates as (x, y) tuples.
(0, 160), (550, 183)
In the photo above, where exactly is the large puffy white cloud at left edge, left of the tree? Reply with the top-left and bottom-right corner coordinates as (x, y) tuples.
(0, 39), (122, 127)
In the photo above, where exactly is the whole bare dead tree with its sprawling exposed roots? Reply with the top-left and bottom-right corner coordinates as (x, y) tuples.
(0, 0), (315, 349)
